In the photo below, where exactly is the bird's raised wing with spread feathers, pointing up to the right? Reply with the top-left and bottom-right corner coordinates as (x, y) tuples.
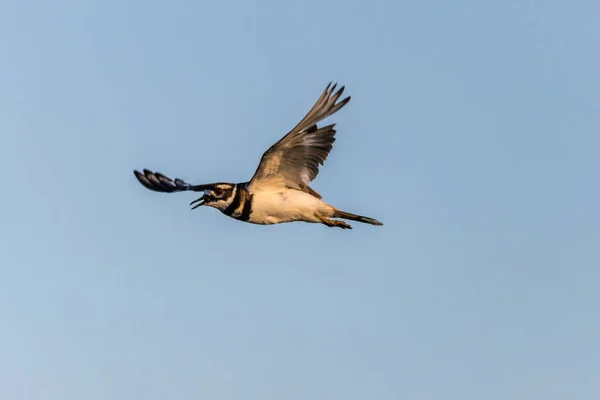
(248, 83), (350, 198)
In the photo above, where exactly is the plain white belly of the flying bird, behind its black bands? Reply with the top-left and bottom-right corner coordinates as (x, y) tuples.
(248, 189), (334, 224)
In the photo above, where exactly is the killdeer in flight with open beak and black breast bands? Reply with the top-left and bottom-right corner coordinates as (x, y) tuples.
(134, 83), (383, 229)
